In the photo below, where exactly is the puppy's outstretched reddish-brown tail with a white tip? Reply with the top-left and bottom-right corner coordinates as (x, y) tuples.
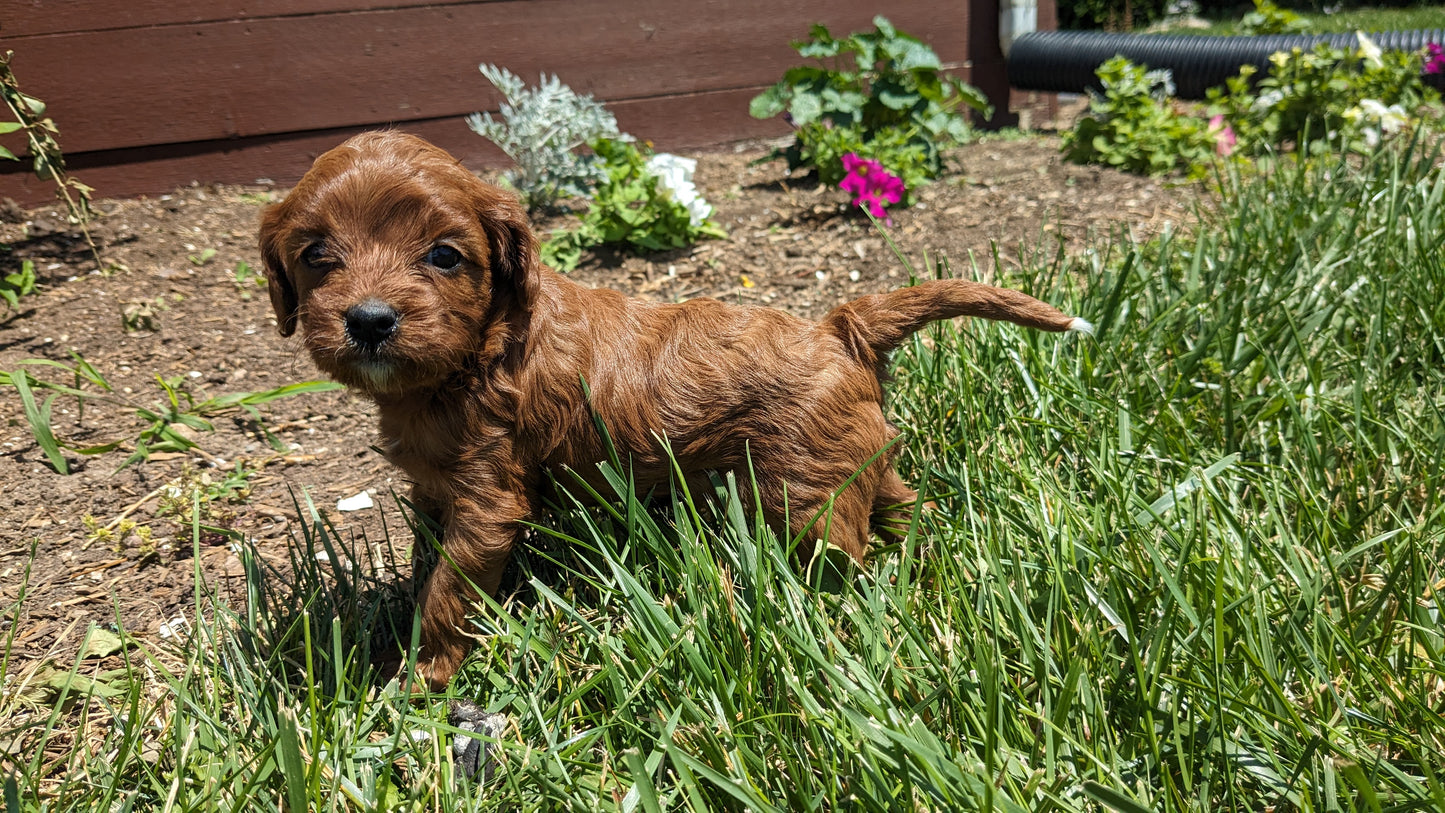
(822, 280), (1094, 362)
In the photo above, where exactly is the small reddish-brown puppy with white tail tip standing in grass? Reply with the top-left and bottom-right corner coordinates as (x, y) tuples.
(260, 133), (1088, 687)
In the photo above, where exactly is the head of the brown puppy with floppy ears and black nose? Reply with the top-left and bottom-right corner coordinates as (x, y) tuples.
(260, 131), (539, 394)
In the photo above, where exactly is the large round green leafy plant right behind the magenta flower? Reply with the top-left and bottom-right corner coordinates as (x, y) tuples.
(749, 16), (991, 188)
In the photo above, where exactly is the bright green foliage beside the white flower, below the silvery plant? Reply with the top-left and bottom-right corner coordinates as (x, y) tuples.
(542, 139), (727, 271)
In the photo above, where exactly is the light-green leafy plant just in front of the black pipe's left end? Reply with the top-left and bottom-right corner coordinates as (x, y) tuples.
(1064, 56), (1217, 175)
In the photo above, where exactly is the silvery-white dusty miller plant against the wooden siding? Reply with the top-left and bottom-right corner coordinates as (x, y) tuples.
(467, 65), (620, 209)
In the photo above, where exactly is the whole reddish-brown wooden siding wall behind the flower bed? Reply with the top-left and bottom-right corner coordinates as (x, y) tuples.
(0, 0), (1001, 202)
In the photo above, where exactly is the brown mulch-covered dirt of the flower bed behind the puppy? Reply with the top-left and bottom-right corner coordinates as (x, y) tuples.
(0, 137), (1194, 660)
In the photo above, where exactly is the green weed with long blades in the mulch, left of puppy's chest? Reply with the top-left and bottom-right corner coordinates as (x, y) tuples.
(0, 352), (341, 474)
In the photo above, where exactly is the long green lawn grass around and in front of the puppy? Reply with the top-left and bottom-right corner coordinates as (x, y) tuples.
(8, 140), (1445, 812)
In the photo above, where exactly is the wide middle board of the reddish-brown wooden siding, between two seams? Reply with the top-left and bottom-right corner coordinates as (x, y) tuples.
(7, 0), (964, 152)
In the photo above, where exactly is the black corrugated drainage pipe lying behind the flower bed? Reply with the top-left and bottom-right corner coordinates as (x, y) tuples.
(1009, 29), (1445, 100)
